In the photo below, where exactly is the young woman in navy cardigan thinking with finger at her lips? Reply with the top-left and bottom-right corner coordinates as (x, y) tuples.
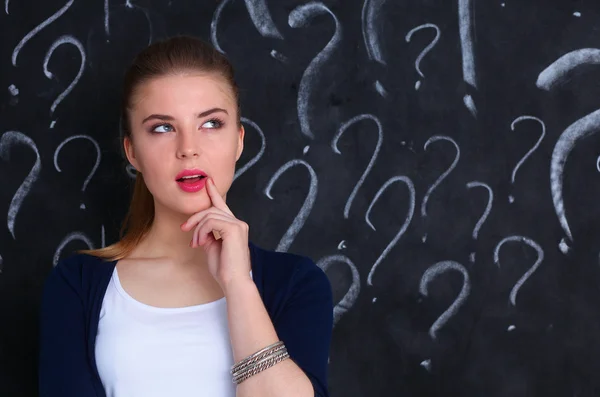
(39, 36), (333, 397)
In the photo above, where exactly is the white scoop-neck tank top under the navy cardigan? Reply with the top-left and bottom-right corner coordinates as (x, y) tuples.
(95, 267), (252, 397)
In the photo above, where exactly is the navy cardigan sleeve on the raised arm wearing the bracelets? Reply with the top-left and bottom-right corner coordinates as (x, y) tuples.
(274, 257), (333, 397)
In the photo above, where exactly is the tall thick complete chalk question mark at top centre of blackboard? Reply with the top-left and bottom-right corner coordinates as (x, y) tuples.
(288, 1), (342, 139)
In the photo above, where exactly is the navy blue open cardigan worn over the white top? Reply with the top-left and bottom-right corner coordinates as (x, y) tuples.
(39, 242), (333, 397)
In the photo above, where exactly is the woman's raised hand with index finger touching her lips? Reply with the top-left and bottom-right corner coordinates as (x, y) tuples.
(181, 178), (252, 293)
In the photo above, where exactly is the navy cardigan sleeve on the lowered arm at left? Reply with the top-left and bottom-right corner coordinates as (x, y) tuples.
(38, 262), (100, 397)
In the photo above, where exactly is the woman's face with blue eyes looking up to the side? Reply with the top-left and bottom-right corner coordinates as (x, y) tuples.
(124, 73), (244, 215)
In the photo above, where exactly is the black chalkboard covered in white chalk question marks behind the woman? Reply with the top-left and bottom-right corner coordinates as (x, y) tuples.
(0, 0), (600, 397)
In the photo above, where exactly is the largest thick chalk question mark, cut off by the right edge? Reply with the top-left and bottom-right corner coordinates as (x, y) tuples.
(536, 48), (600, 254)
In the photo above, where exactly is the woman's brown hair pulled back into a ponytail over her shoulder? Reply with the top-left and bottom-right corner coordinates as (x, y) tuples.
(77, 35), (241, 261)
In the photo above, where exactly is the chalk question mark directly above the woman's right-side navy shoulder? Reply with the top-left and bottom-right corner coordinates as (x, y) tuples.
(265, 159), (319, 252)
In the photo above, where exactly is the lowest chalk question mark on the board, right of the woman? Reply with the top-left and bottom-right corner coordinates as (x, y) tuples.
(419, 261), (471, 339)
